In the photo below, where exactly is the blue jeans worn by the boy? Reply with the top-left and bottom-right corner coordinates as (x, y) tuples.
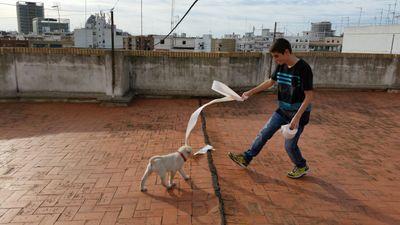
(244, 112), (306, 167)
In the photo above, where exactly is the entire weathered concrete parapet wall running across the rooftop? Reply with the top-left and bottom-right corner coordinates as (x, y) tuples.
(0, 48), (400, 98)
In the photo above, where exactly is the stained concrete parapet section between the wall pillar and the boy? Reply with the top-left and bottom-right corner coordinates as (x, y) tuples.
(125, 54), (264, 96)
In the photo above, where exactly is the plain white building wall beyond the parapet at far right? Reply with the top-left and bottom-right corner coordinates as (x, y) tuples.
(342, 25), (400, 54)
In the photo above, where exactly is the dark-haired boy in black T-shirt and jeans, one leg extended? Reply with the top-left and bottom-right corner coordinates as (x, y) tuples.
(228, 38), (313, 178)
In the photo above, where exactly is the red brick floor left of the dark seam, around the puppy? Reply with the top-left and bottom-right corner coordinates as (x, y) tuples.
(0, 99), (220, 225)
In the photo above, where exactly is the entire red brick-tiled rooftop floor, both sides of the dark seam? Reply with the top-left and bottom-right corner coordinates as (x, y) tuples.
(0, 91), (400, 225)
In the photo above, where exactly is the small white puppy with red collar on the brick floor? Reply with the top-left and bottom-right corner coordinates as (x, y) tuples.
(140, 145), (192, 191)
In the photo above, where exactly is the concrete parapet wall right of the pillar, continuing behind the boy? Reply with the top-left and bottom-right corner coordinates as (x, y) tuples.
(125, 51), (400, 96)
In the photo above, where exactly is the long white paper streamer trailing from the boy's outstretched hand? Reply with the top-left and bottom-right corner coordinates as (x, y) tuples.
(185, 80), (243, 145)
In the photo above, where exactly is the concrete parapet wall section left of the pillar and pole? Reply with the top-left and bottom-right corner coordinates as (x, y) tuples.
(0, 48), (127, 99)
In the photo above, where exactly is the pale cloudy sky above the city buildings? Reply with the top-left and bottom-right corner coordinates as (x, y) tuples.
(0, 0), (400, 37)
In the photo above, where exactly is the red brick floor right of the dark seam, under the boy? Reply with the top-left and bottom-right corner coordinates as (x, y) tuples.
(206, 91), (400, 225)
